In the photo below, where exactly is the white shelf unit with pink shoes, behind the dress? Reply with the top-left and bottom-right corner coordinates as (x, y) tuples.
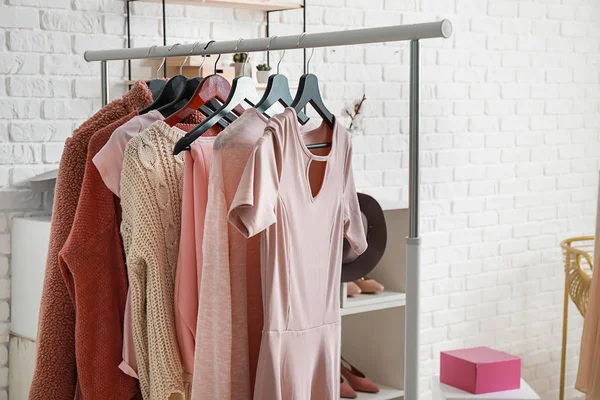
(341, 207), (409, 400)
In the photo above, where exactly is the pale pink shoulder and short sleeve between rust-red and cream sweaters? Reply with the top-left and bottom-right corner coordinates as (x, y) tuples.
(92, 110), (164, 197)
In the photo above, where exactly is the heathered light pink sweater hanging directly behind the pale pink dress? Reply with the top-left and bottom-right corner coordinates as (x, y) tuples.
(192, 109), (266, 400)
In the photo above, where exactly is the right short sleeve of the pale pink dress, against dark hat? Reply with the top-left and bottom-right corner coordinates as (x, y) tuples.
(344, 147), (367, 255)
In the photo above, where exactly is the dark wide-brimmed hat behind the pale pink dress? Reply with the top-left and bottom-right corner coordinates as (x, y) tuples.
(342, 193), (387, 282)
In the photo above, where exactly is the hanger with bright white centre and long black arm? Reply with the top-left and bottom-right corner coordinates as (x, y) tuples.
(173, 39), (258, 155)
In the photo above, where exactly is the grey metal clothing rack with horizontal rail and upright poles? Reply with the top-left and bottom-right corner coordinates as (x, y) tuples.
(84, 20), (452, 400)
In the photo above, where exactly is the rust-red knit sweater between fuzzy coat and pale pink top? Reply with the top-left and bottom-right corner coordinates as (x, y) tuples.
(59, 112), (139, 400)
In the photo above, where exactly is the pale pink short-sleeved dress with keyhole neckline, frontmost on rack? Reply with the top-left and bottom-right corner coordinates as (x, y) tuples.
(228, 108), (367, 400)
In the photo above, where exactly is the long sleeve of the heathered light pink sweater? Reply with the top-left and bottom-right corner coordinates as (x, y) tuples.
(192, 184), (232, 400)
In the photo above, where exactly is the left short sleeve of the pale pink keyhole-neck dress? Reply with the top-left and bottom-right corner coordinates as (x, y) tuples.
(228, 129), (282, 238)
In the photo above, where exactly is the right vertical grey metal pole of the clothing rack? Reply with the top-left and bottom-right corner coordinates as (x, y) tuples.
(404, 40), (421, 400)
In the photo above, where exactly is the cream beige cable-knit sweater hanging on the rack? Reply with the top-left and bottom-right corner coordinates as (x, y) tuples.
(121, 121), (188, 400)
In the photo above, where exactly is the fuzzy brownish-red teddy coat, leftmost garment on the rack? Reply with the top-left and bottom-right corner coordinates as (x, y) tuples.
(29, 82), (152, 400)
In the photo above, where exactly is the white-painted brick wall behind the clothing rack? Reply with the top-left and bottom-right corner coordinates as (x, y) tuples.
(0, 0), (600, 400)
